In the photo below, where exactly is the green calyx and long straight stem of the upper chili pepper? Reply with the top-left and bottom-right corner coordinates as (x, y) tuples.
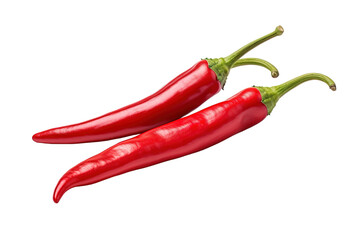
(205, 26), (284, 88)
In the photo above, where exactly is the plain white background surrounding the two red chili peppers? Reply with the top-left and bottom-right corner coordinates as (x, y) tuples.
(0, 0), (360, 240)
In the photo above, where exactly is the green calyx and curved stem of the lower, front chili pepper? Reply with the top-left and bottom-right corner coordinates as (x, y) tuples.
(256, 73), (336, 114)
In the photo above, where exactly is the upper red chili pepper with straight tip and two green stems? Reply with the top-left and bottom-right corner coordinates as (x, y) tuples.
(33, 26), (283, 143)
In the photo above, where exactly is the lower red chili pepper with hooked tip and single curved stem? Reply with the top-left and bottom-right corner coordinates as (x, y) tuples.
(54, 73), (336, 203)
